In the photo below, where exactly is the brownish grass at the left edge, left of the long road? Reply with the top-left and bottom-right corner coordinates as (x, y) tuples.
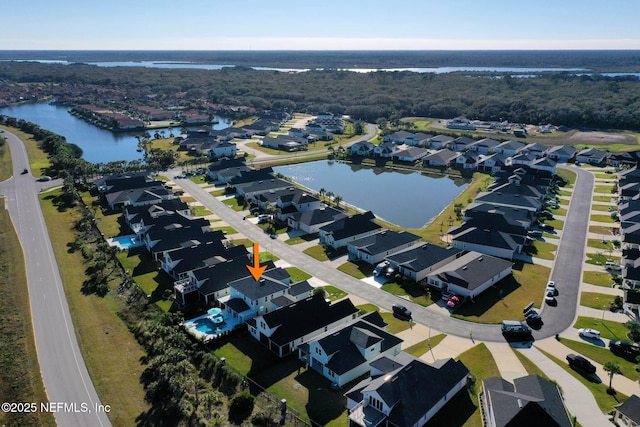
(0, 209), (56, 426)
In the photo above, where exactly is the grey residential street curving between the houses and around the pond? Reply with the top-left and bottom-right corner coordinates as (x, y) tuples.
(172, 162), (593, 342)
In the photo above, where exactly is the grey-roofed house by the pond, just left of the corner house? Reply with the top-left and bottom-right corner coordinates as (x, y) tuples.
(385, 243), (463, 282)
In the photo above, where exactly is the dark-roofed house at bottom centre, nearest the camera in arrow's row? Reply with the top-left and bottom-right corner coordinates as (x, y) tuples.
(345, 352), (469, 427)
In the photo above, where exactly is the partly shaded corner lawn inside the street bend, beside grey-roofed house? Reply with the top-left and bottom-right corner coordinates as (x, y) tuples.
(452, 263), (551, 323)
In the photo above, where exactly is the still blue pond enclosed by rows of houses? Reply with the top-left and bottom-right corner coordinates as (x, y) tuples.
(273, 161), (469, 228)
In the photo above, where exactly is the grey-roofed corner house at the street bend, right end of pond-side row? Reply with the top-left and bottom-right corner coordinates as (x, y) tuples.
(427, 251), (512, 299)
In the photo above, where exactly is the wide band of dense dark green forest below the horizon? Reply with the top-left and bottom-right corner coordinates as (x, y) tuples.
(0, 57), (640, 129)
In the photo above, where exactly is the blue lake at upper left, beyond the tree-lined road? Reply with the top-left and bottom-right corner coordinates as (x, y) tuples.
(0, 103), (230, 163)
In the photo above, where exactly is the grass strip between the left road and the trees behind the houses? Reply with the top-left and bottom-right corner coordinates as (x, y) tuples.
(41, 190), (149, 426)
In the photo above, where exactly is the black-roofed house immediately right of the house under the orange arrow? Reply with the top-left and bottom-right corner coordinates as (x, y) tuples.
(247, 294), (358, 357)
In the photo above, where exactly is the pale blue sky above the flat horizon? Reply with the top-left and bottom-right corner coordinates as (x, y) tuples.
(5, 0), (640, 50)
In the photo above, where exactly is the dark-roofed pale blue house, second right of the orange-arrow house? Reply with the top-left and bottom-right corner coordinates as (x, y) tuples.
(298, 311), (402, 387)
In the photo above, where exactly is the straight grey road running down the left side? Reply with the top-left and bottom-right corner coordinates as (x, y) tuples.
(0, 131), (114, 427)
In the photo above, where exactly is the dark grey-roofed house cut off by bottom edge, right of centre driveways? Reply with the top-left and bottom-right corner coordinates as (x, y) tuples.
(480, 375), (573, 427)
